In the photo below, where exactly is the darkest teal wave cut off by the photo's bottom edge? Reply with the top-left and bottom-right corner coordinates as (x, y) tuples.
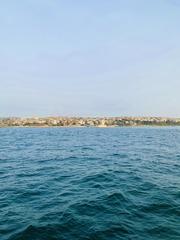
(9, 219), (132, 240)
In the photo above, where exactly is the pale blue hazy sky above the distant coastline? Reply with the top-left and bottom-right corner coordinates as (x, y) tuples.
(0, 0), (180, 117)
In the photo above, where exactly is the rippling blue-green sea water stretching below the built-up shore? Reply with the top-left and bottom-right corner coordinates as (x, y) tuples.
(0, 127), (180, 240)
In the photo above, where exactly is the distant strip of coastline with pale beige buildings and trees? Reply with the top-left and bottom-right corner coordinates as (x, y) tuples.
(0, 117), (180, 128)
